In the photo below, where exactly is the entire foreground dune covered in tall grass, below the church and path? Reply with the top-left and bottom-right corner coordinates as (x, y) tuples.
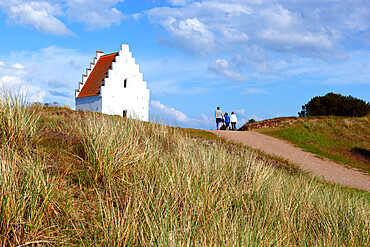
(0, 92), (370, 246)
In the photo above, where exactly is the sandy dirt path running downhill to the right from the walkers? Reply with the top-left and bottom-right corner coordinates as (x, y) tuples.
(210, 130), (370, 190)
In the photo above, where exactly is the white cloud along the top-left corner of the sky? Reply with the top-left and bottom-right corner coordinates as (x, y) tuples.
(0, 0), (124, 35)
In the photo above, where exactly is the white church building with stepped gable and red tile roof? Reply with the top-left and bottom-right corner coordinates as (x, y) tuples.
(76, 44), (150, 121)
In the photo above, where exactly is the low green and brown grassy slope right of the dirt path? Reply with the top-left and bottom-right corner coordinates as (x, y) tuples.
(258, 116), (370, 174)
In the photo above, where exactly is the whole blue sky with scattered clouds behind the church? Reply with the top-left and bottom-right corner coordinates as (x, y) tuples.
(0, 0), (370, 129)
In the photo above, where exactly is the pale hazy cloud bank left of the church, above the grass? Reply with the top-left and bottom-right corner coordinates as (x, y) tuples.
(0, 46), (92, 105)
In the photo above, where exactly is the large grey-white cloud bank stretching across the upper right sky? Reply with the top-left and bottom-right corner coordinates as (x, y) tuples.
(146, 0), (370, 60)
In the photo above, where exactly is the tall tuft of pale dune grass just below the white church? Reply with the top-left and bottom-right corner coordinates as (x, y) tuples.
(75, 114), (150, 185)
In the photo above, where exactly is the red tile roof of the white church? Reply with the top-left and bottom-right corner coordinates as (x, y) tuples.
(77, 52), (118, 98)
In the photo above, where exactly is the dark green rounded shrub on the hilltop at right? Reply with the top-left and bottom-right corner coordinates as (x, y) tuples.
(298, 93), (370, 117)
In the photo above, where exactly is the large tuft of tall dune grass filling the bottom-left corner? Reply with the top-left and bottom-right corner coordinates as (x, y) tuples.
(0, 146), (65, 246)
